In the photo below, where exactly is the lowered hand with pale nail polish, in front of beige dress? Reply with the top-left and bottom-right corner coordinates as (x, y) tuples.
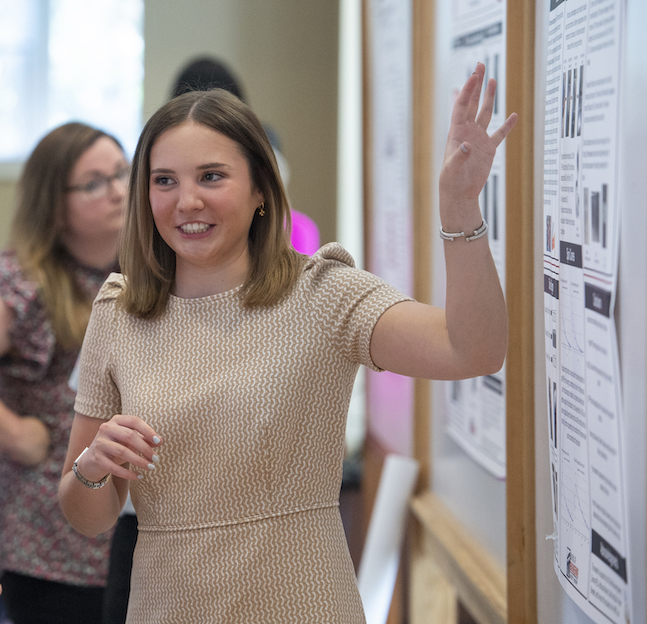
(78, 414), (162, 481)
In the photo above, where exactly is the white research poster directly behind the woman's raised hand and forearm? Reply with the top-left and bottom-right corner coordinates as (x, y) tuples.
(446, 0), (506, 479)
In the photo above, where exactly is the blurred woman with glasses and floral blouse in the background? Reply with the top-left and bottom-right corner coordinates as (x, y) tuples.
(0, 123), (129, 624)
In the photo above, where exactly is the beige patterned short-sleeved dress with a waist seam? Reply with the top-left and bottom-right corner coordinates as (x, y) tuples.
(75, 244), (406, 624)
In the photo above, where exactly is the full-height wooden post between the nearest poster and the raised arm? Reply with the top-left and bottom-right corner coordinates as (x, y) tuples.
(506, 0), (537, 624)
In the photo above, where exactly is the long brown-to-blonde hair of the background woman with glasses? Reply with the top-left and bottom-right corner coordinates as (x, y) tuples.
(9, 122), (123, 347)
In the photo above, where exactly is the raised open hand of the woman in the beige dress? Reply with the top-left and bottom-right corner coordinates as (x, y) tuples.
(440, 63), (517, 217)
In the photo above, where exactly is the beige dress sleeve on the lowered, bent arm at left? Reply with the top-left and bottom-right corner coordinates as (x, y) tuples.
(74, 273), (124, 420)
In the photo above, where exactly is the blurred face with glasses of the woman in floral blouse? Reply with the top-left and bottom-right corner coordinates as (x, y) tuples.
(63, 137), (128, 249)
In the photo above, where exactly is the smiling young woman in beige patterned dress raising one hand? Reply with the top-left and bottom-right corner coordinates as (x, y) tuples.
(59, 65), (515, 624)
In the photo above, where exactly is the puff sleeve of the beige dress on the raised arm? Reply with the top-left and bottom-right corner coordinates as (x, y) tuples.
(304, 243), (412, 371)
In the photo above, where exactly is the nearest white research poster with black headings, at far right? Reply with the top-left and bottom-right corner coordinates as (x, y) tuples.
(542, 0), (631, 624)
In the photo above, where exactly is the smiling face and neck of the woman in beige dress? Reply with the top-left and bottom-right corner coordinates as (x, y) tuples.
(149, 121), (263, 287)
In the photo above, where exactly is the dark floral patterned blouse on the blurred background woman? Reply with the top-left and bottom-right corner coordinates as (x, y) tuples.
(0, 251), (111, 586)
